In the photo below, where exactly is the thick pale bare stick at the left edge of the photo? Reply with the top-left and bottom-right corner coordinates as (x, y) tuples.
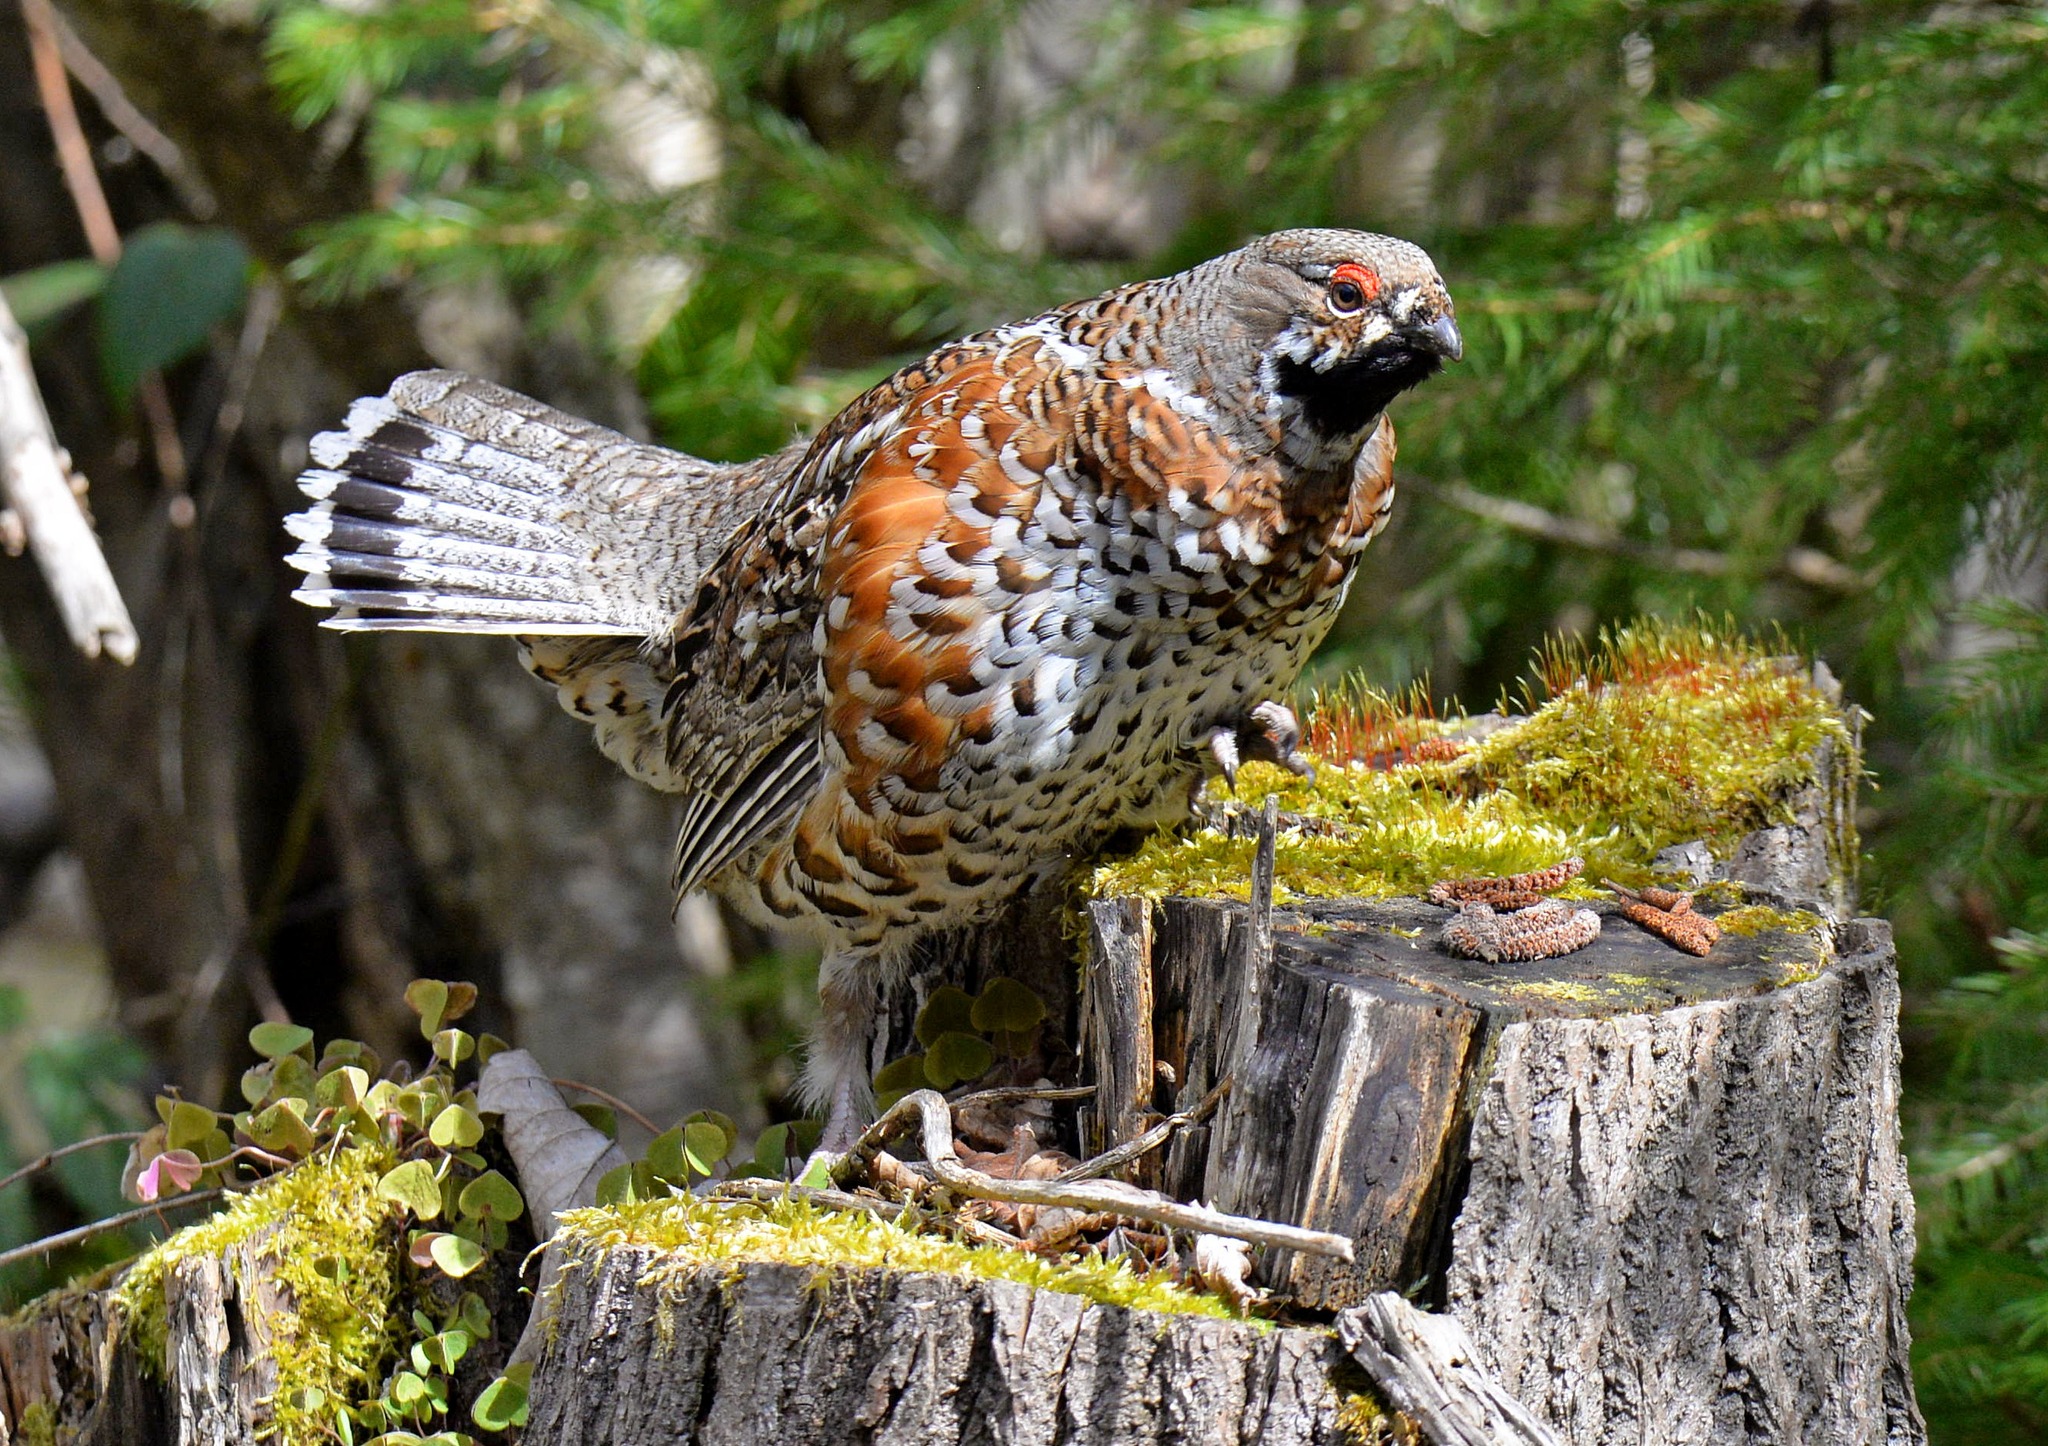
(0, 286), (139, 664)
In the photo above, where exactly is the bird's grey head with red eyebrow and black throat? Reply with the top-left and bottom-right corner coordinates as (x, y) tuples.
(1225, 229), (1464, 444)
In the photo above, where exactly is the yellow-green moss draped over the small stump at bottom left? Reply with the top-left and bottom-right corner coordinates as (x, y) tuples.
(115, 1149), (399, 1446)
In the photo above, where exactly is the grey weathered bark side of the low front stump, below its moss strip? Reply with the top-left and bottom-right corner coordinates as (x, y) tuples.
(526, 1249), (1343, 1446)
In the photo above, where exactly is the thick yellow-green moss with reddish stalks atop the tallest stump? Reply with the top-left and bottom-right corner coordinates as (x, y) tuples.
(1092, 623), (1851, 901)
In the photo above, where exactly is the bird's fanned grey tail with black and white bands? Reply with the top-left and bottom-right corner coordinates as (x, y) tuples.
(285, 371), (659, 635)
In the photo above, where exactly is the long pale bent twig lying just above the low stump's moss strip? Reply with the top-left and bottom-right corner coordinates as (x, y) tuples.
(831, 1090), (1352, 1262)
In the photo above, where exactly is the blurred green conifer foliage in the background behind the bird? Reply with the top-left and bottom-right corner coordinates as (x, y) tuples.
(0, 0), (2048, 1446)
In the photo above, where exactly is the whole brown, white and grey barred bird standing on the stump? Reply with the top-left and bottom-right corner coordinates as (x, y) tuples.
(289, 231), (1460, 1139)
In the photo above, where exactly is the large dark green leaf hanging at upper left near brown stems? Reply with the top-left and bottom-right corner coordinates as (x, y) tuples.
(100, 221), (250, 401)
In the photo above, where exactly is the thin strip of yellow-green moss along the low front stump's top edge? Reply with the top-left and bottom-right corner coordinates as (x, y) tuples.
(555, 1196), (1241, 1321)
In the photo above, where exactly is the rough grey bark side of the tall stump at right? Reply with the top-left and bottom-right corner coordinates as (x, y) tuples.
(1448, 922), (1925, 1444)
